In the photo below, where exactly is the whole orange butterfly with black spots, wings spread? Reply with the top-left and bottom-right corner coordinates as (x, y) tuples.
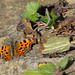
(0, 38), (36, 61)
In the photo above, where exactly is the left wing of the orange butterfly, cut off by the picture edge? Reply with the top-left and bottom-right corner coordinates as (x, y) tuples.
(0, 46), (11, 60)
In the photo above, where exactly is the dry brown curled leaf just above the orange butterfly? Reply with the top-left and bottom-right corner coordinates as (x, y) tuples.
(17, 18), (41, 43)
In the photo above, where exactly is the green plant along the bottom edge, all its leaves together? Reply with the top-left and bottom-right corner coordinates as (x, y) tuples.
(24, 56), (69, 75)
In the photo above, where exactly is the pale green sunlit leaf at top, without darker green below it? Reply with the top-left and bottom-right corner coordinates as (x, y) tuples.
(22, 1), (40, 18)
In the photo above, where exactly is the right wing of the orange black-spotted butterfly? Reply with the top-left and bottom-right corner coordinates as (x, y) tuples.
(16, 38), (34, 56)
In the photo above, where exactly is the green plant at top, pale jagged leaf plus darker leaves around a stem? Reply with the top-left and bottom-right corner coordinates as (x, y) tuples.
(22, 1), (58, 27)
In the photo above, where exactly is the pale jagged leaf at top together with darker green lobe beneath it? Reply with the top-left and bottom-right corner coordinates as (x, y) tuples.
(22, 1), (40, 22)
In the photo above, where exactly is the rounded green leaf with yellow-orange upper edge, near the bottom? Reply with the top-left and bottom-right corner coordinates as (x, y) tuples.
(37, 63), (55, 72)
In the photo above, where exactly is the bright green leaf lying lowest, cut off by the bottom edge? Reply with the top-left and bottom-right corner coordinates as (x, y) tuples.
(24, 70), (53, 75)
